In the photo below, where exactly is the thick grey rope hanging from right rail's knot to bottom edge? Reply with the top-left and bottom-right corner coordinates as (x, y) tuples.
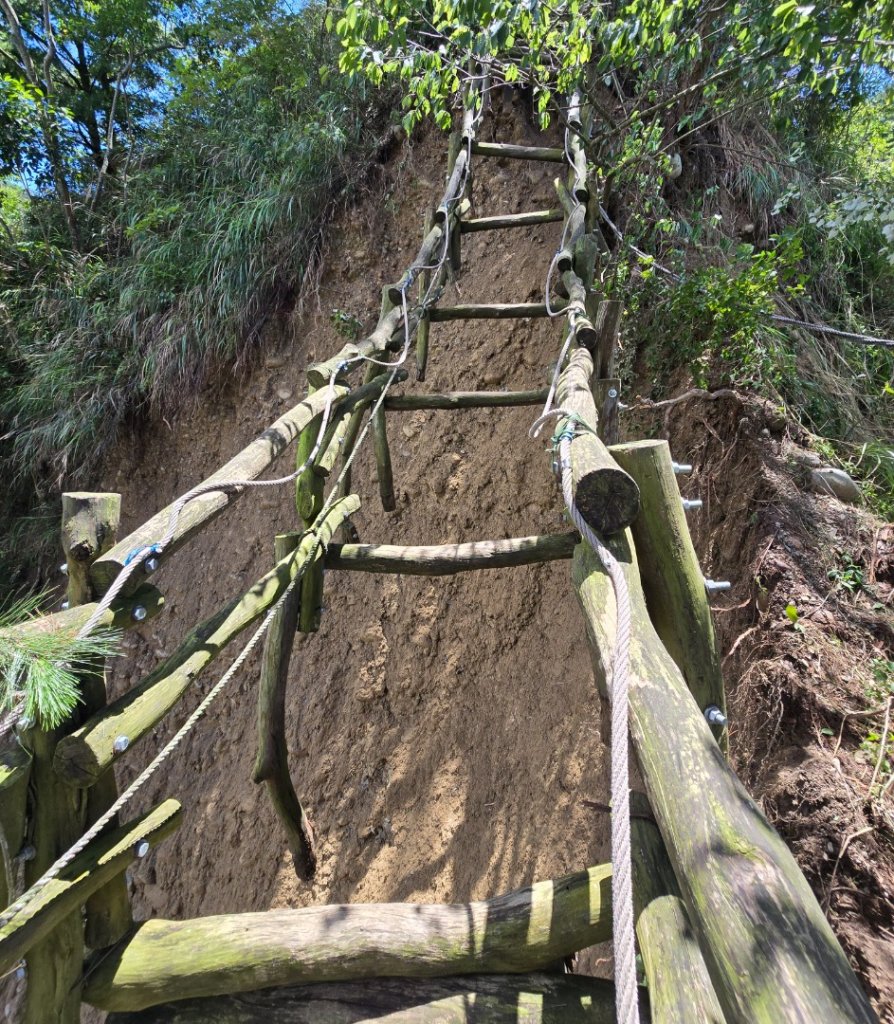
(559, 427), (639, 1024)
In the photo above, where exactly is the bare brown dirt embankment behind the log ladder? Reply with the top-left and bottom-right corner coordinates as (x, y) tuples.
(80, 103), (894, 1013)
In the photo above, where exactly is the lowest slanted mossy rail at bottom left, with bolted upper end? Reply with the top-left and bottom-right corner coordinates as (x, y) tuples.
(0, 800), (180, 978)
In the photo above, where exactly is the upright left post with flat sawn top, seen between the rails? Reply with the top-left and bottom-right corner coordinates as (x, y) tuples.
(59, 492), (133, 949)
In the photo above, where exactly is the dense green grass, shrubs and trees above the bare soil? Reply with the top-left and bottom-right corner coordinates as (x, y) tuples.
(0, 0), (894, 598)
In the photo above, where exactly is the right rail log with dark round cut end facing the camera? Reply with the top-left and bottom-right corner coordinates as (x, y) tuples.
(556, 348), (639, 535)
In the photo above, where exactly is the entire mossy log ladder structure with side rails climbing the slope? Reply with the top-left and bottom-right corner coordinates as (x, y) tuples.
(0, 81), (875, 1024)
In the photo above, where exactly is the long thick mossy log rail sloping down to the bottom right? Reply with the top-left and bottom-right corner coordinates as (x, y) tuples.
(572, 532), (877, 1024)
